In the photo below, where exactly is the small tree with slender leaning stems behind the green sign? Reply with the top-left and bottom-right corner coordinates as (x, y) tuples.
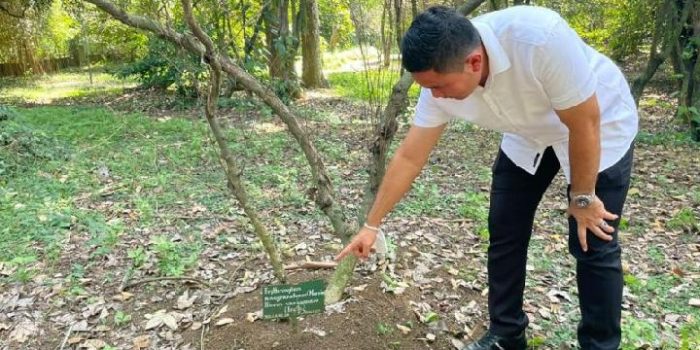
(84, 0), (485, 303)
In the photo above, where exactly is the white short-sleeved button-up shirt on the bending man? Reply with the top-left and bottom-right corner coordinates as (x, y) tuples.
(414, 6), (638, 182)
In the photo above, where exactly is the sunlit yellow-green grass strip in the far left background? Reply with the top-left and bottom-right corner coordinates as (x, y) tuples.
(0, 71), (136, 104)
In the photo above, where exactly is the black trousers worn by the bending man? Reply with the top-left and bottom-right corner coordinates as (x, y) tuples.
(488, 147), (633, 349)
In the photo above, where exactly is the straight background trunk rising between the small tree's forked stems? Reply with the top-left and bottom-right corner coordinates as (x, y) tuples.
(300, 0), (328, 88)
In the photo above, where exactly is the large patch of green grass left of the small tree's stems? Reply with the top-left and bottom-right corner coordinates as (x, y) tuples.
(0, 107), (206, 274)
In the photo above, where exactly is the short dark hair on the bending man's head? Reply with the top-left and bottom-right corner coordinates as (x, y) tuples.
(401, 6), (481, 73)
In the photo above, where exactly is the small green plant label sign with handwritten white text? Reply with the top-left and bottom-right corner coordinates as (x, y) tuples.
(263, 280), (326, 319)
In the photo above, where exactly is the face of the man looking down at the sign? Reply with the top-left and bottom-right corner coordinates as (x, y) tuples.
(412, 52), (483, 100)
